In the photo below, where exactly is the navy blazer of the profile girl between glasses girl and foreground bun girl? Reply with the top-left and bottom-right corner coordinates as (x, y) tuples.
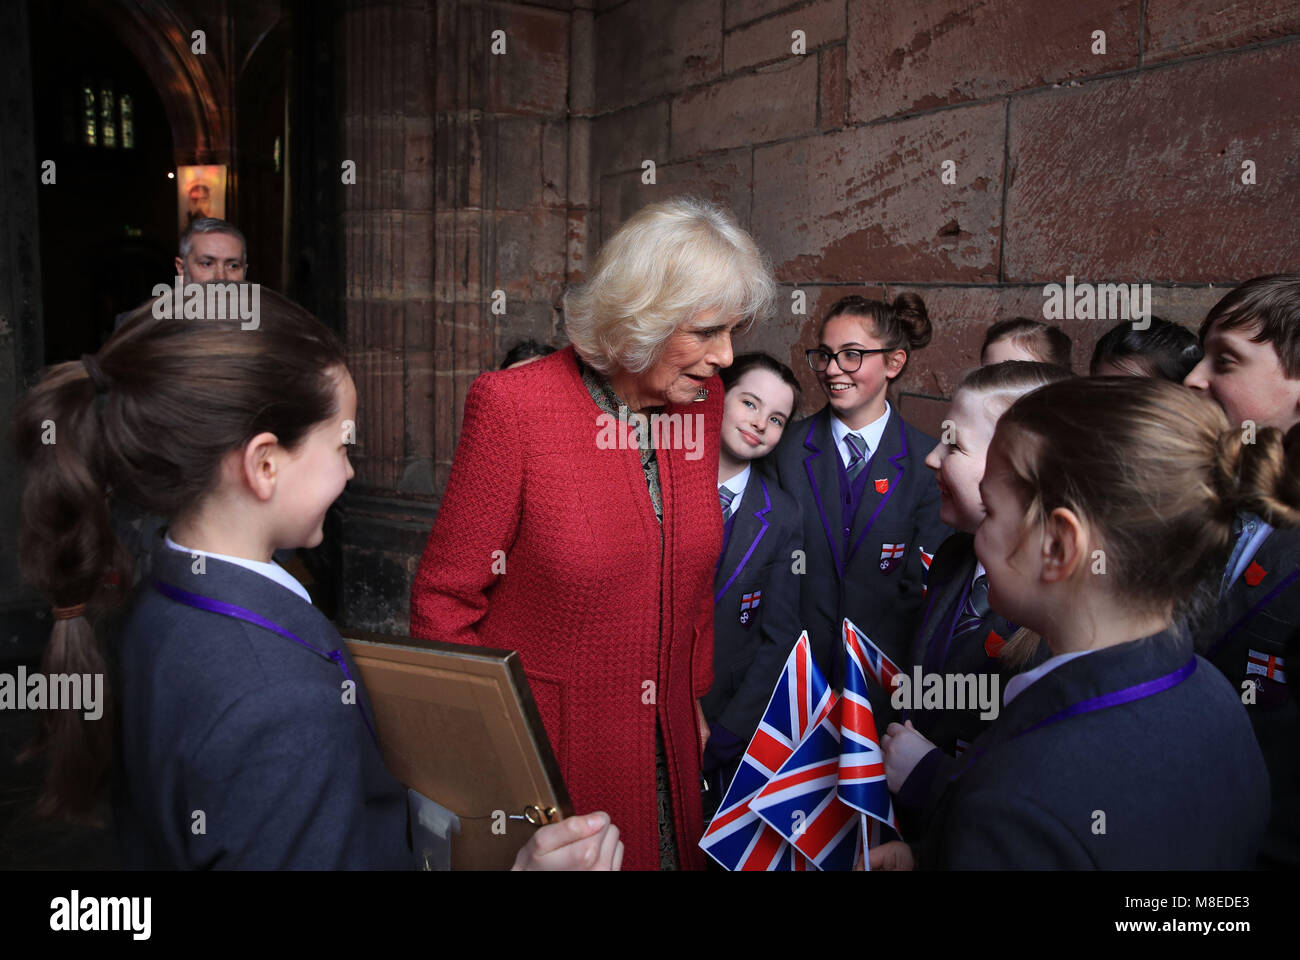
(900, 532), (1052, 754)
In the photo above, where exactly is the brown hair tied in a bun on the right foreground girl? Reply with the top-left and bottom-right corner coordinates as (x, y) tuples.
(995, 377), (1300, 628)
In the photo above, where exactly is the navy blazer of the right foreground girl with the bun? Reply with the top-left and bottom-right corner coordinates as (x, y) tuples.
(904, 632), (1269, 870)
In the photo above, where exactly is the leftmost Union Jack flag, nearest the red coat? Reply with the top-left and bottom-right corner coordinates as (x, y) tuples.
(699, 631), (835, 870)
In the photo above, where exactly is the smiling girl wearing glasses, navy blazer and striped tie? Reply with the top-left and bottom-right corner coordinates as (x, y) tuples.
(772, 299), (949, 723)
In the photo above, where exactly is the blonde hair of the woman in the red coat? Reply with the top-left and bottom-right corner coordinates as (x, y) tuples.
(564, 198), (776, 375)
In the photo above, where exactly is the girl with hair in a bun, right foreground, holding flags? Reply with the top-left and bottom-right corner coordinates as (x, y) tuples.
(871, 377), (1268, 869)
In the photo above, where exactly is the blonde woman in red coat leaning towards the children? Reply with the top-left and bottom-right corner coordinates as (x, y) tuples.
(411, 200), (775, 869)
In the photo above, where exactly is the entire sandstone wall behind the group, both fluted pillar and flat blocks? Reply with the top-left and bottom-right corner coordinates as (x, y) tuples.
(342, 0), (1300, 632)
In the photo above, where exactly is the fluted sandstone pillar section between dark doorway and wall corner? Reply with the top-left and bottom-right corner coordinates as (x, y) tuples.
(339, 0), (579, 633)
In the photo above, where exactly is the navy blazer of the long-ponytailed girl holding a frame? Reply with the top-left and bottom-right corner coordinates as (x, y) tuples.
(113, 531), (412, 869)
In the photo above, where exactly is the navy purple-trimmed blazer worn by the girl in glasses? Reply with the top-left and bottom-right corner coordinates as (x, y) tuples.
(770, 405), (952, 697)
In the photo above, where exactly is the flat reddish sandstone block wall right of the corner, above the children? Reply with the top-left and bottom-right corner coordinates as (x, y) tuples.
(589, 0), (1300, 429)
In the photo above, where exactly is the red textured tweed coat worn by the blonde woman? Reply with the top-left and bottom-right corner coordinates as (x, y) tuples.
(411, 347), (723, 869)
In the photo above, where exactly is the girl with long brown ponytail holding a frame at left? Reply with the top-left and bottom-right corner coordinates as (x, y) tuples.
(16, 291), (618, 869)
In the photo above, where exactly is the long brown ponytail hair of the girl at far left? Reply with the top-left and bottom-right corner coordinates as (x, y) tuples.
(14, 290), (346, 820)
